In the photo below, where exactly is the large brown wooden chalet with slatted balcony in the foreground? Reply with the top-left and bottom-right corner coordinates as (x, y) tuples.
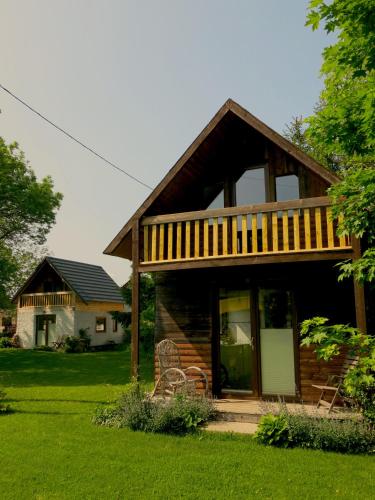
(105, 100), (366, 401)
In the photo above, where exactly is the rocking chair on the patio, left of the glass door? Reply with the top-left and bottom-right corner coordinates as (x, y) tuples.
(151, 339), (212, 397)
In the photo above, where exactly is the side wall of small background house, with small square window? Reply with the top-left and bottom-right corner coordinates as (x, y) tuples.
(75, 311), (123, 346)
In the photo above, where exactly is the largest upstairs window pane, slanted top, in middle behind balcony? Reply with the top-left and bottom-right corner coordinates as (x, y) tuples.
(236, 167), (266, 206)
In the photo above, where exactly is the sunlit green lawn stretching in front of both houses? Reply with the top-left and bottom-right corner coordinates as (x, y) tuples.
(0, 349), (375, 500)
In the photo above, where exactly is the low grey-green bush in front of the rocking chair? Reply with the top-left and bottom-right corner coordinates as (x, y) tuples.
(93, 383), (215, 435)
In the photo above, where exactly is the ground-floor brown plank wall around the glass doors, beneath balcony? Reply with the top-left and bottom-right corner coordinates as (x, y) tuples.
(155, 262), (355, 402)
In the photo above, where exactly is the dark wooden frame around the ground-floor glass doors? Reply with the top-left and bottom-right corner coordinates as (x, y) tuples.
(211, 280), (301, 401)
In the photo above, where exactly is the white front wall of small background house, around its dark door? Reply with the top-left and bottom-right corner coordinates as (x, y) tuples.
(16, 306), (74, 349)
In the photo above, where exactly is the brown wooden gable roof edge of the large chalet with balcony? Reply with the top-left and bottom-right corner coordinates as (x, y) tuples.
(104, 99), (339, 256)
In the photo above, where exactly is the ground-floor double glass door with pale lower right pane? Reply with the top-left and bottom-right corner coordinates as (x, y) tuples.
(217, 287), (296, 396)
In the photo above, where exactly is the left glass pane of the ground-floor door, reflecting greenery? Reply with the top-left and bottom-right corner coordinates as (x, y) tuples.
(219, 289), (255, 392)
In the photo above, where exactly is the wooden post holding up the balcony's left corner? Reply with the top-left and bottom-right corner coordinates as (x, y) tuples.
(131, 220), (140, 379)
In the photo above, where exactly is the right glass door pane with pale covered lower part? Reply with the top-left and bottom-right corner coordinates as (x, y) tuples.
(259, 289), (296, 396)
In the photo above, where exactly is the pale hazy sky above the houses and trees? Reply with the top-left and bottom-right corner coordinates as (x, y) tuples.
(0, 0), (328, 284)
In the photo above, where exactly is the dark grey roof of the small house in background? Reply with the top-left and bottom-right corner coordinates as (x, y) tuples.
(13, 257), (124, 303)
